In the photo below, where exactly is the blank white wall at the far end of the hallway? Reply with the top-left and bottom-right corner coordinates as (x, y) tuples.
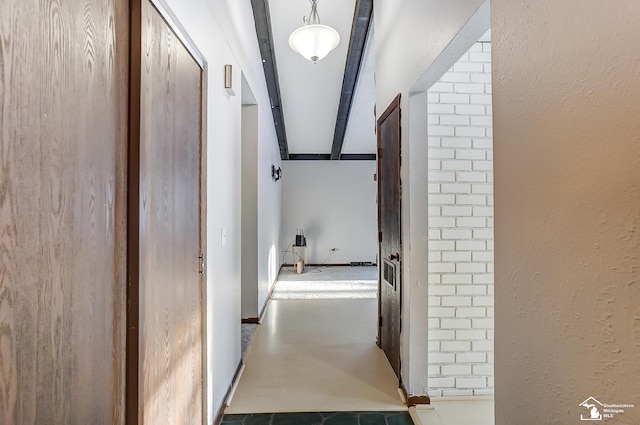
(280, 161), (378, 264)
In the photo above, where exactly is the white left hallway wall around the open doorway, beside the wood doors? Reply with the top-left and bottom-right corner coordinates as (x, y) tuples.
(159, 0), (280, 423)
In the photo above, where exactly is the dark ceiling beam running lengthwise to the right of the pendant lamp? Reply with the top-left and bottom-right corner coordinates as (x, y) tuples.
(331, 0), (373, 159)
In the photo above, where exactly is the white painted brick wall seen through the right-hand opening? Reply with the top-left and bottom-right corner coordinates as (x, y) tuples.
(428, 37), (493, 397)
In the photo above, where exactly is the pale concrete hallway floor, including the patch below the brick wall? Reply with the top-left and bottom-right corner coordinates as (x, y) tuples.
(226, 267), (494, 425)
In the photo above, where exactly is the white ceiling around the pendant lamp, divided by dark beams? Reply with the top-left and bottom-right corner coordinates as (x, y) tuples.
(269, 0), (376, 154)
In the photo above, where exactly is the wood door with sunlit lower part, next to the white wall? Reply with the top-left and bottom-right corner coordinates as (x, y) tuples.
(128, 0), (203, 425)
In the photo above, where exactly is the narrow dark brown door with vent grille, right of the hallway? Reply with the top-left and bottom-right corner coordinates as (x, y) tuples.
(378, 95), (402, 378)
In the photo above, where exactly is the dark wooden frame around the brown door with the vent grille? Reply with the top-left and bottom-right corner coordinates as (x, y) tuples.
(376, 93), (403, 374)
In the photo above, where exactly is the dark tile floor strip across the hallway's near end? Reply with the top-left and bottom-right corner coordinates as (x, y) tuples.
(221, 412), (413, 425)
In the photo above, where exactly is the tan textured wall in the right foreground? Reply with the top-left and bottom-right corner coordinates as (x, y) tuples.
(491, 0), (640, 425)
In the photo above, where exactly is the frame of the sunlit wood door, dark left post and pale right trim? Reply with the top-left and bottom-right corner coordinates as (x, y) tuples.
(125, 0), (209, 425)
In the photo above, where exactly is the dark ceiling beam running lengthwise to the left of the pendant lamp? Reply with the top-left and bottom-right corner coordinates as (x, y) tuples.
(251, 0), (289, 160)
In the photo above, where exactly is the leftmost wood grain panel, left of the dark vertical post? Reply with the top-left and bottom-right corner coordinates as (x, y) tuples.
(0, 0), (129, 425)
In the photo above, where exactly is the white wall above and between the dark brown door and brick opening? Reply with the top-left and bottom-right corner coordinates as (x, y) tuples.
(374, 0), (489, 395)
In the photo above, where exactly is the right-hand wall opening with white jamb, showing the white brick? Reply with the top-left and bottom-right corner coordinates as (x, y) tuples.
(403, 2), (494, 424)
